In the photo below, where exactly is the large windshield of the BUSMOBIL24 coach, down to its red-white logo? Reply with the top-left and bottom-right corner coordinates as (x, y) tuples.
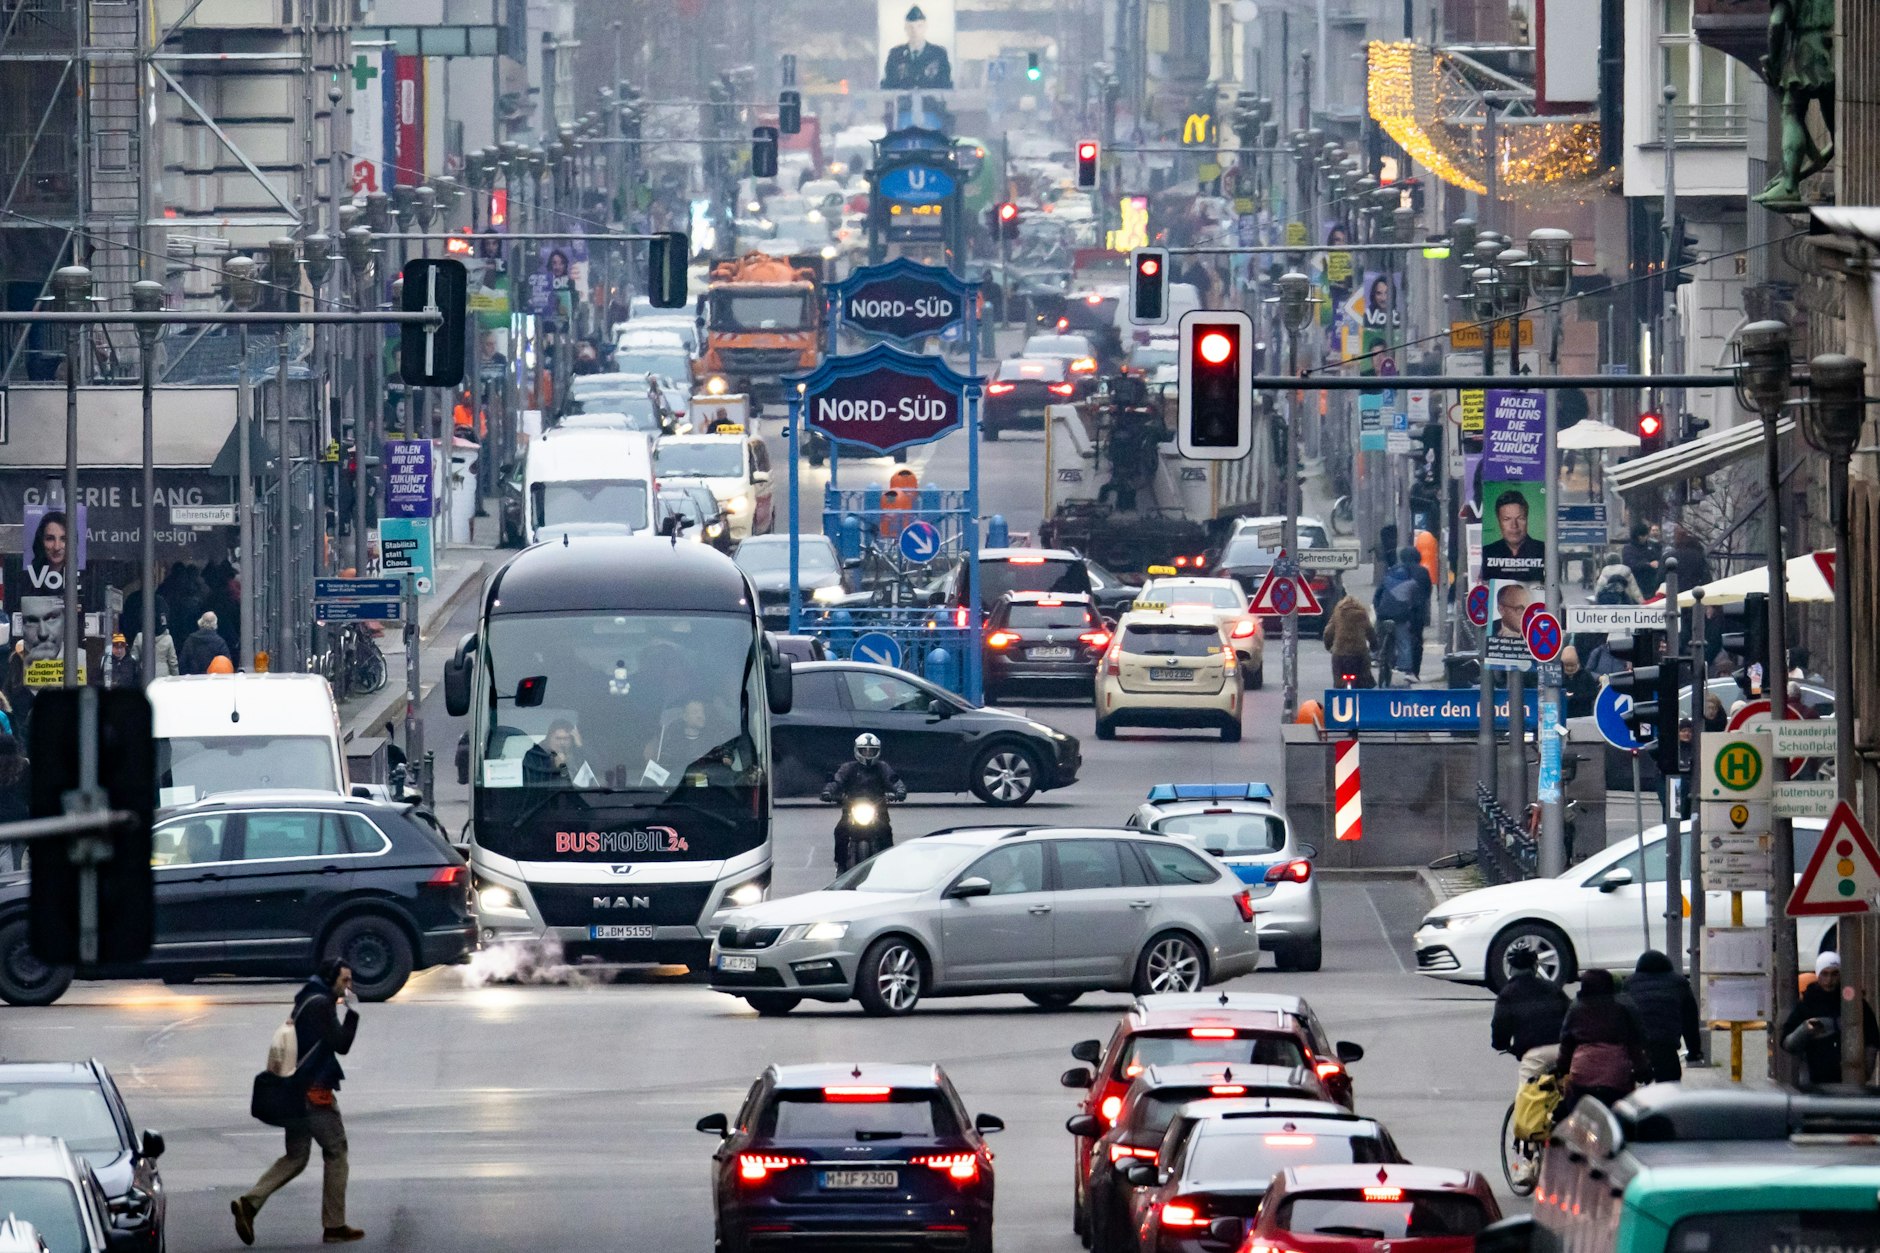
(476, 611), (769, 860)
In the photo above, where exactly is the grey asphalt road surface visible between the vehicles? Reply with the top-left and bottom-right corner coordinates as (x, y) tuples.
(0, 385), (1513, 1253)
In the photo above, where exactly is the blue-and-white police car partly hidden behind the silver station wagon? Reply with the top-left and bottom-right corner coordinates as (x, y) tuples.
(1126, 783), (1324, 971)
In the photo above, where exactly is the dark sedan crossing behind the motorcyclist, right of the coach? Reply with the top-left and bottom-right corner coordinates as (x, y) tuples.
(771, 662), (1083, 805)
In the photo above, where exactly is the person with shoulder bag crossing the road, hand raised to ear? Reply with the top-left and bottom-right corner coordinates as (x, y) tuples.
(229, 958), (365, 1244)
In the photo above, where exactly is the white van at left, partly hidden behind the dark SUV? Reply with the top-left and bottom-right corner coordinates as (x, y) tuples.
(150, 674), (348, 805)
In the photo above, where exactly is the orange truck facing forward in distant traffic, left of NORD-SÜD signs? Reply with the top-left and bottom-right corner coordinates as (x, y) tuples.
(699, 252), (823, 404)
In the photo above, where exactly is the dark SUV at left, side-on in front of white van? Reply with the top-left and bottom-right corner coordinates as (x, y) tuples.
(0, 792), (476, 1005)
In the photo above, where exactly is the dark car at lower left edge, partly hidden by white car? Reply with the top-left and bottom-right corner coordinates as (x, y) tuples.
(0, 1061), (169, 1253)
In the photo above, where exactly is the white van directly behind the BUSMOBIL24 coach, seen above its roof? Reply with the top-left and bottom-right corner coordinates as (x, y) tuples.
(523, 429), (658, 544)
